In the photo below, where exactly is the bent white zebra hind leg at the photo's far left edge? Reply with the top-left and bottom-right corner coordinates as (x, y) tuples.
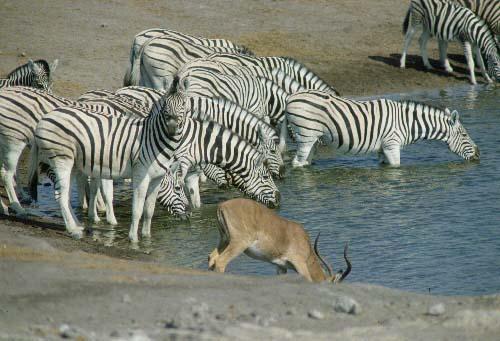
(0, 143), (26, 215)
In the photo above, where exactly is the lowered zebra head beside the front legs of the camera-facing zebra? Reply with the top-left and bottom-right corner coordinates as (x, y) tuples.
(157, 166), (190, 218)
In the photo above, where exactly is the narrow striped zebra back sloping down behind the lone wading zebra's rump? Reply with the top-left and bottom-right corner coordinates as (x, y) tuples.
(205, 53), (339, 95)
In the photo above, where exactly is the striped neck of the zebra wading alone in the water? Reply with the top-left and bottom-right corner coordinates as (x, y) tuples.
(400, 102), (450, 145)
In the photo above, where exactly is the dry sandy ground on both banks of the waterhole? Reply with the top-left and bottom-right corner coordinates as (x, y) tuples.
(0, 0), (500, 340)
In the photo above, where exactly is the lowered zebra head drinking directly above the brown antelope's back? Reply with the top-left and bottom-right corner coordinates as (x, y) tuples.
(227, 155), (281, 208)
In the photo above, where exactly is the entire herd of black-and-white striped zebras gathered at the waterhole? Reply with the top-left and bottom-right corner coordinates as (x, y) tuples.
(0, 0), (492, 242)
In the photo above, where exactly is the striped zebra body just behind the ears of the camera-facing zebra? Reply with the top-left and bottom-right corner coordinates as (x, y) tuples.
(179, 69), (289, 125)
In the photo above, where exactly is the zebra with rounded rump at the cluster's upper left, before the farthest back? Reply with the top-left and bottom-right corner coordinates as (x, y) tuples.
(123, 35), (252, 89)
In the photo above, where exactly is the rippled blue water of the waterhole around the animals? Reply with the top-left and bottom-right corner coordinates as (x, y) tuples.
(28, 86), (500, 295)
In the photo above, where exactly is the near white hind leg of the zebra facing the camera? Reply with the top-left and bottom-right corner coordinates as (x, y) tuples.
(52, 159), (83, 239)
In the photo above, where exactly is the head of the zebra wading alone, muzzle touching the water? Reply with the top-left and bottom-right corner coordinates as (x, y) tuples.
(446, 109), (479, 160)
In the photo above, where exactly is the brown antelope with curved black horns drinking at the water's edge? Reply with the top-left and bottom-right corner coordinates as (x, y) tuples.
(208, 198), (351, 283)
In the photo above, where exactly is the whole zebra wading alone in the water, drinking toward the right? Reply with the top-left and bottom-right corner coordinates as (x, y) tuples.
(286, 91), (479, 167)
